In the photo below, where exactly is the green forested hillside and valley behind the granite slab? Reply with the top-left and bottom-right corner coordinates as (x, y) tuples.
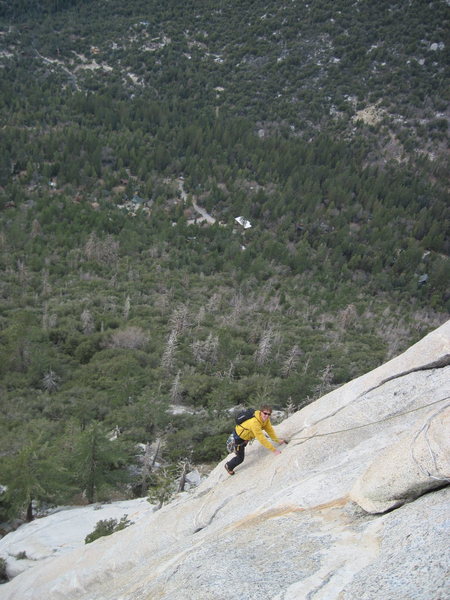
(0, 0), (450, 518)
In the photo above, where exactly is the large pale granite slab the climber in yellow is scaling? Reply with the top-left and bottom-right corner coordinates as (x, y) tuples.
(0, 322), (450, 600)
